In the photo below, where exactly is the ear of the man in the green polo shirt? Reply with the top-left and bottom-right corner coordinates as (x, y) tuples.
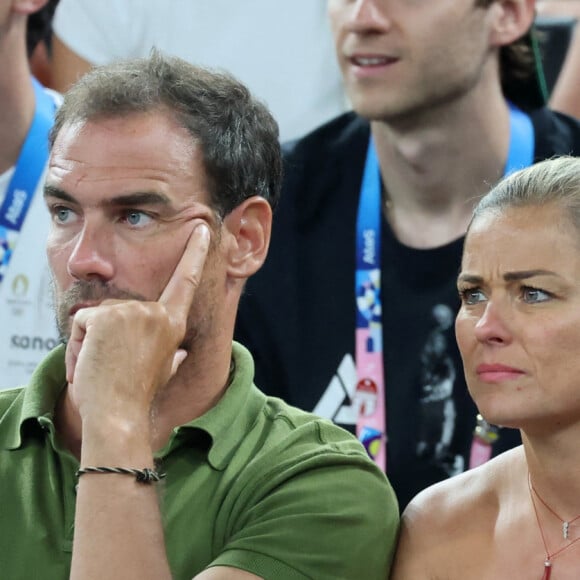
(224, 195), (272, 278)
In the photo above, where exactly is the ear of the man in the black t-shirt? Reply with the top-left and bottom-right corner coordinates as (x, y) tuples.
(489, 0), (536, 47)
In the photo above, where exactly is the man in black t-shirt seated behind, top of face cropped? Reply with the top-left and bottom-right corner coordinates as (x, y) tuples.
(237, 0), (580, 507)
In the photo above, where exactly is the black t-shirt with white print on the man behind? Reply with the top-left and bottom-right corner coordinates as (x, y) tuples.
(236, 109), (580, 508)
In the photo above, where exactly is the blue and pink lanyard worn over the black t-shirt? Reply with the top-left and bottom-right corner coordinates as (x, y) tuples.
(354, 104), (535, 470)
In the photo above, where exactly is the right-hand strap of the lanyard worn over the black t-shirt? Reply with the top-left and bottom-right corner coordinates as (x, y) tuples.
(469, 103), (535, 469)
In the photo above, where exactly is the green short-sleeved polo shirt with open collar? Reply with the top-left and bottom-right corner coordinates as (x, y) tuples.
(0, 343), (399, 580)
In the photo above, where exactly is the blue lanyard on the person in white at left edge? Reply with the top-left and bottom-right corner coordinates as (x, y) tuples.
(0, 78), (56, 283)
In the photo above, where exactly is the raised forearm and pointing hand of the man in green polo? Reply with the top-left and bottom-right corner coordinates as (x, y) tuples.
(65, 225), (209, 580)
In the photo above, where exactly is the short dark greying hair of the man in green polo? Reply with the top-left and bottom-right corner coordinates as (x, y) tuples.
(50, 51), (282, 217)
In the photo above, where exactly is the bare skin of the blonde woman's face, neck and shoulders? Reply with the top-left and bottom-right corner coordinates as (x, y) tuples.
(392, 205), (580, 580)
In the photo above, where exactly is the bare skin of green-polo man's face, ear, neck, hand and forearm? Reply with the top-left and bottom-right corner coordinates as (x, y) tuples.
(45, 110), (271, 580)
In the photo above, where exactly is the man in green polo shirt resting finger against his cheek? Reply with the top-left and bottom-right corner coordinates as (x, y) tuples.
(0, 53), (399, 580)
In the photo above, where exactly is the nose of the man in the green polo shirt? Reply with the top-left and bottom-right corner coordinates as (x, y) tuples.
(67, 222), (115, 282)
